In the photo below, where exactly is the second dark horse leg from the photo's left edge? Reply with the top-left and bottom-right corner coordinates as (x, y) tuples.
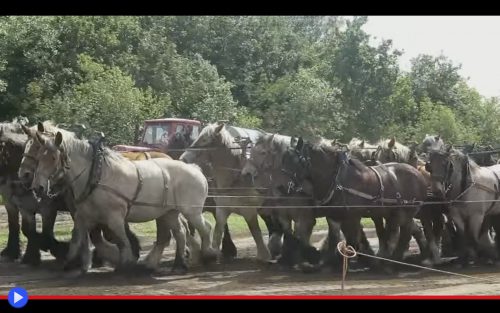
(21, 211), (41, 266)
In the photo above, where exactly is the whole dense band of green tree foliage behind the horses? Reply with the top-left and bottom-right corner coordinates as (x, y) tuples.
(0, 16), (500, 144)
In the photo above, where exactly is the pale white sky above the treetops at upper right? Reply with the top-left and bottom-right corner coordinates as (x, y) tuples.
(363, 16), (500, 97)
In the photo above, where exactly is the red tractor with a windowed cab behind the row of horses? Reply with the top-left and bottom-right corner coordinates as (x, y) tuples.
(113, 118), (201, 159)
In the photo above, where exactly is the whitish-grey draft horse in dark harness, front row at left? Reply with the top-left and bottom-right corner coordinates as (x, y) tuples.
(32, 132), (215, 270)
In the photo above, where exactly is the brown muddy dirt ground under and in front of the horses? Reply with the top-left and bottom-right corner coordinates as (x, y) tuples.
(0, 207), (500, 295)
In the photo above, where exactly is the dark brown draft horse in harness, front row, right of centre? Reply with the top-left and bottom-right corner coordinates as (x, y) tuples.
(282, 138), (427, 270)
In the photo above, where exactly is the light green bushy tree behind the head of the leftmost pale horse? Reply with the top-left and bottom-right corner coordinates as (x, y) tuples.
(40, 55), (164, 145)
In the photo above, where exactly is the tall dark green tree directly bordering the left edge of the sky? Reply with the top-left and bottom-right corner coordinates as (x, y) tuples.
(326, 17), (401, 140)
